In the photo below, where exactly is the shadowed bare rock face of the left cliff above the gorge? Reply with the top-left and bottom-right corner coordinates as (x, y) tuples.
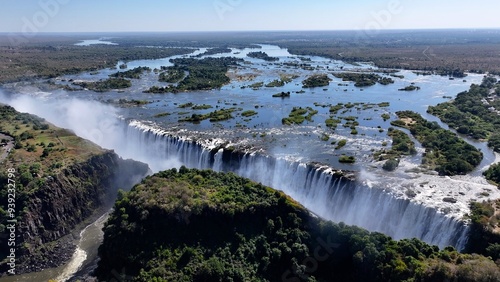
(18, 152), (149, 271)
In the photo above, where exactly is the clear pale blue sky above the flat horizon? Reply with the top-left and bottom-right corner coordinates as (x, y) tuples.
(0, 0), (500, 32)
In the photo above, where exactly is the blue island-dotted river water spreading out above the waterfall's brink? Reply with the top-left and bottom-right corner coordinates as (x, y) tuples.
(21, 45), (488, 170)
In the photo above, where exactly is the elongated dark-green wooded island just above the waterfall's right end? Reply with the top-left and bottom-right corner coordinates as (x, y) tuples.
(391, 111), (483, 175)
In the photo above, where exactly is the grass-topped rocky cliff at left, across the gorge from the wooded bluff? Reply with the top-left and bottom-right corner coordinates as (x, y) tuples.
(0, 104), (149, 274)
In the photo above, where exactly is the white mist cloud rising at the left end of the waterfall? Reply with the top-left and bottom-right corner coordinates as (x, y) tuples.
(0, 90), (182, 172)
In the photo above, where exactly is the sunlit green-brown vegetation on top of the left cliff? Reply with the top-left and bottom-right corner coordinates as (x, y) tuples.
(0, 105), (105, 231)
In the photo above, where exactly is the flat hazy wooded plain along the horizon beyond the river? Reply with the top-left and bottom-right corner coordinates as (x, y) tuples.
(0, 30), (500, 83)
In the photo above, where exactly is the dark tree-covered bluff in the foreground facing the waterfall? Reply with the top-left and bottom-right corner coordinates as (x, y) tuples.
(97, 167), (500, 281)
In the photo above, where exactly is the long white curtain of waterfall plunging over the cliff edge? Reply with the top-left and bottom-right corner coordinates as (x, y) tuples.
(123, 122), (468, 250)
